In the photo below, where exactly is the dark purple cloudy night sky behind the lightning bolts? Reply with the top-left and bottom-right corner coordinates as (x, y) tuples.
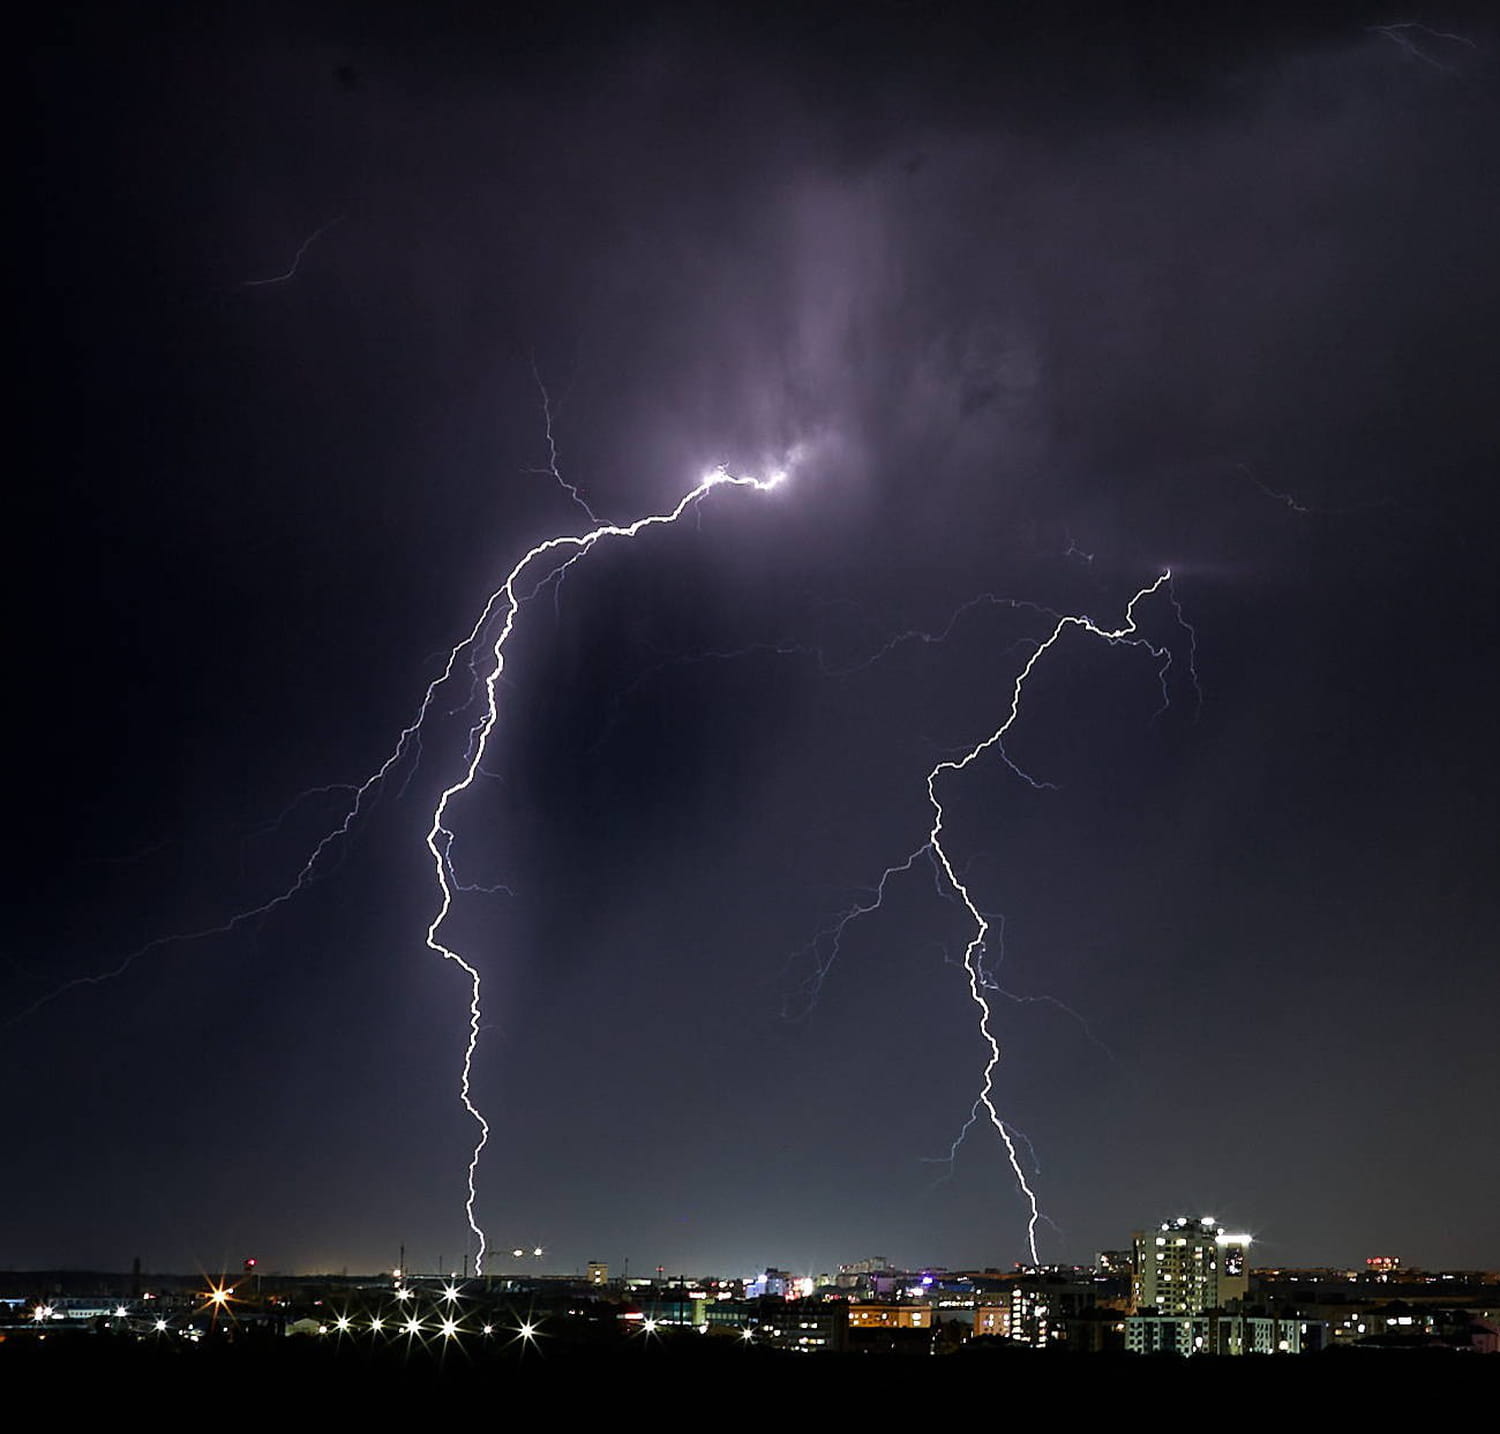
(14, 3), (1500, 1274)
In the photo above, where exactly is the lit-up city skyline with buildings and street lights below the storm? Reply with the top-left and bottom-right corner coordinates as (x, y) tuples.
(0, 1217), (1500, 1367)
